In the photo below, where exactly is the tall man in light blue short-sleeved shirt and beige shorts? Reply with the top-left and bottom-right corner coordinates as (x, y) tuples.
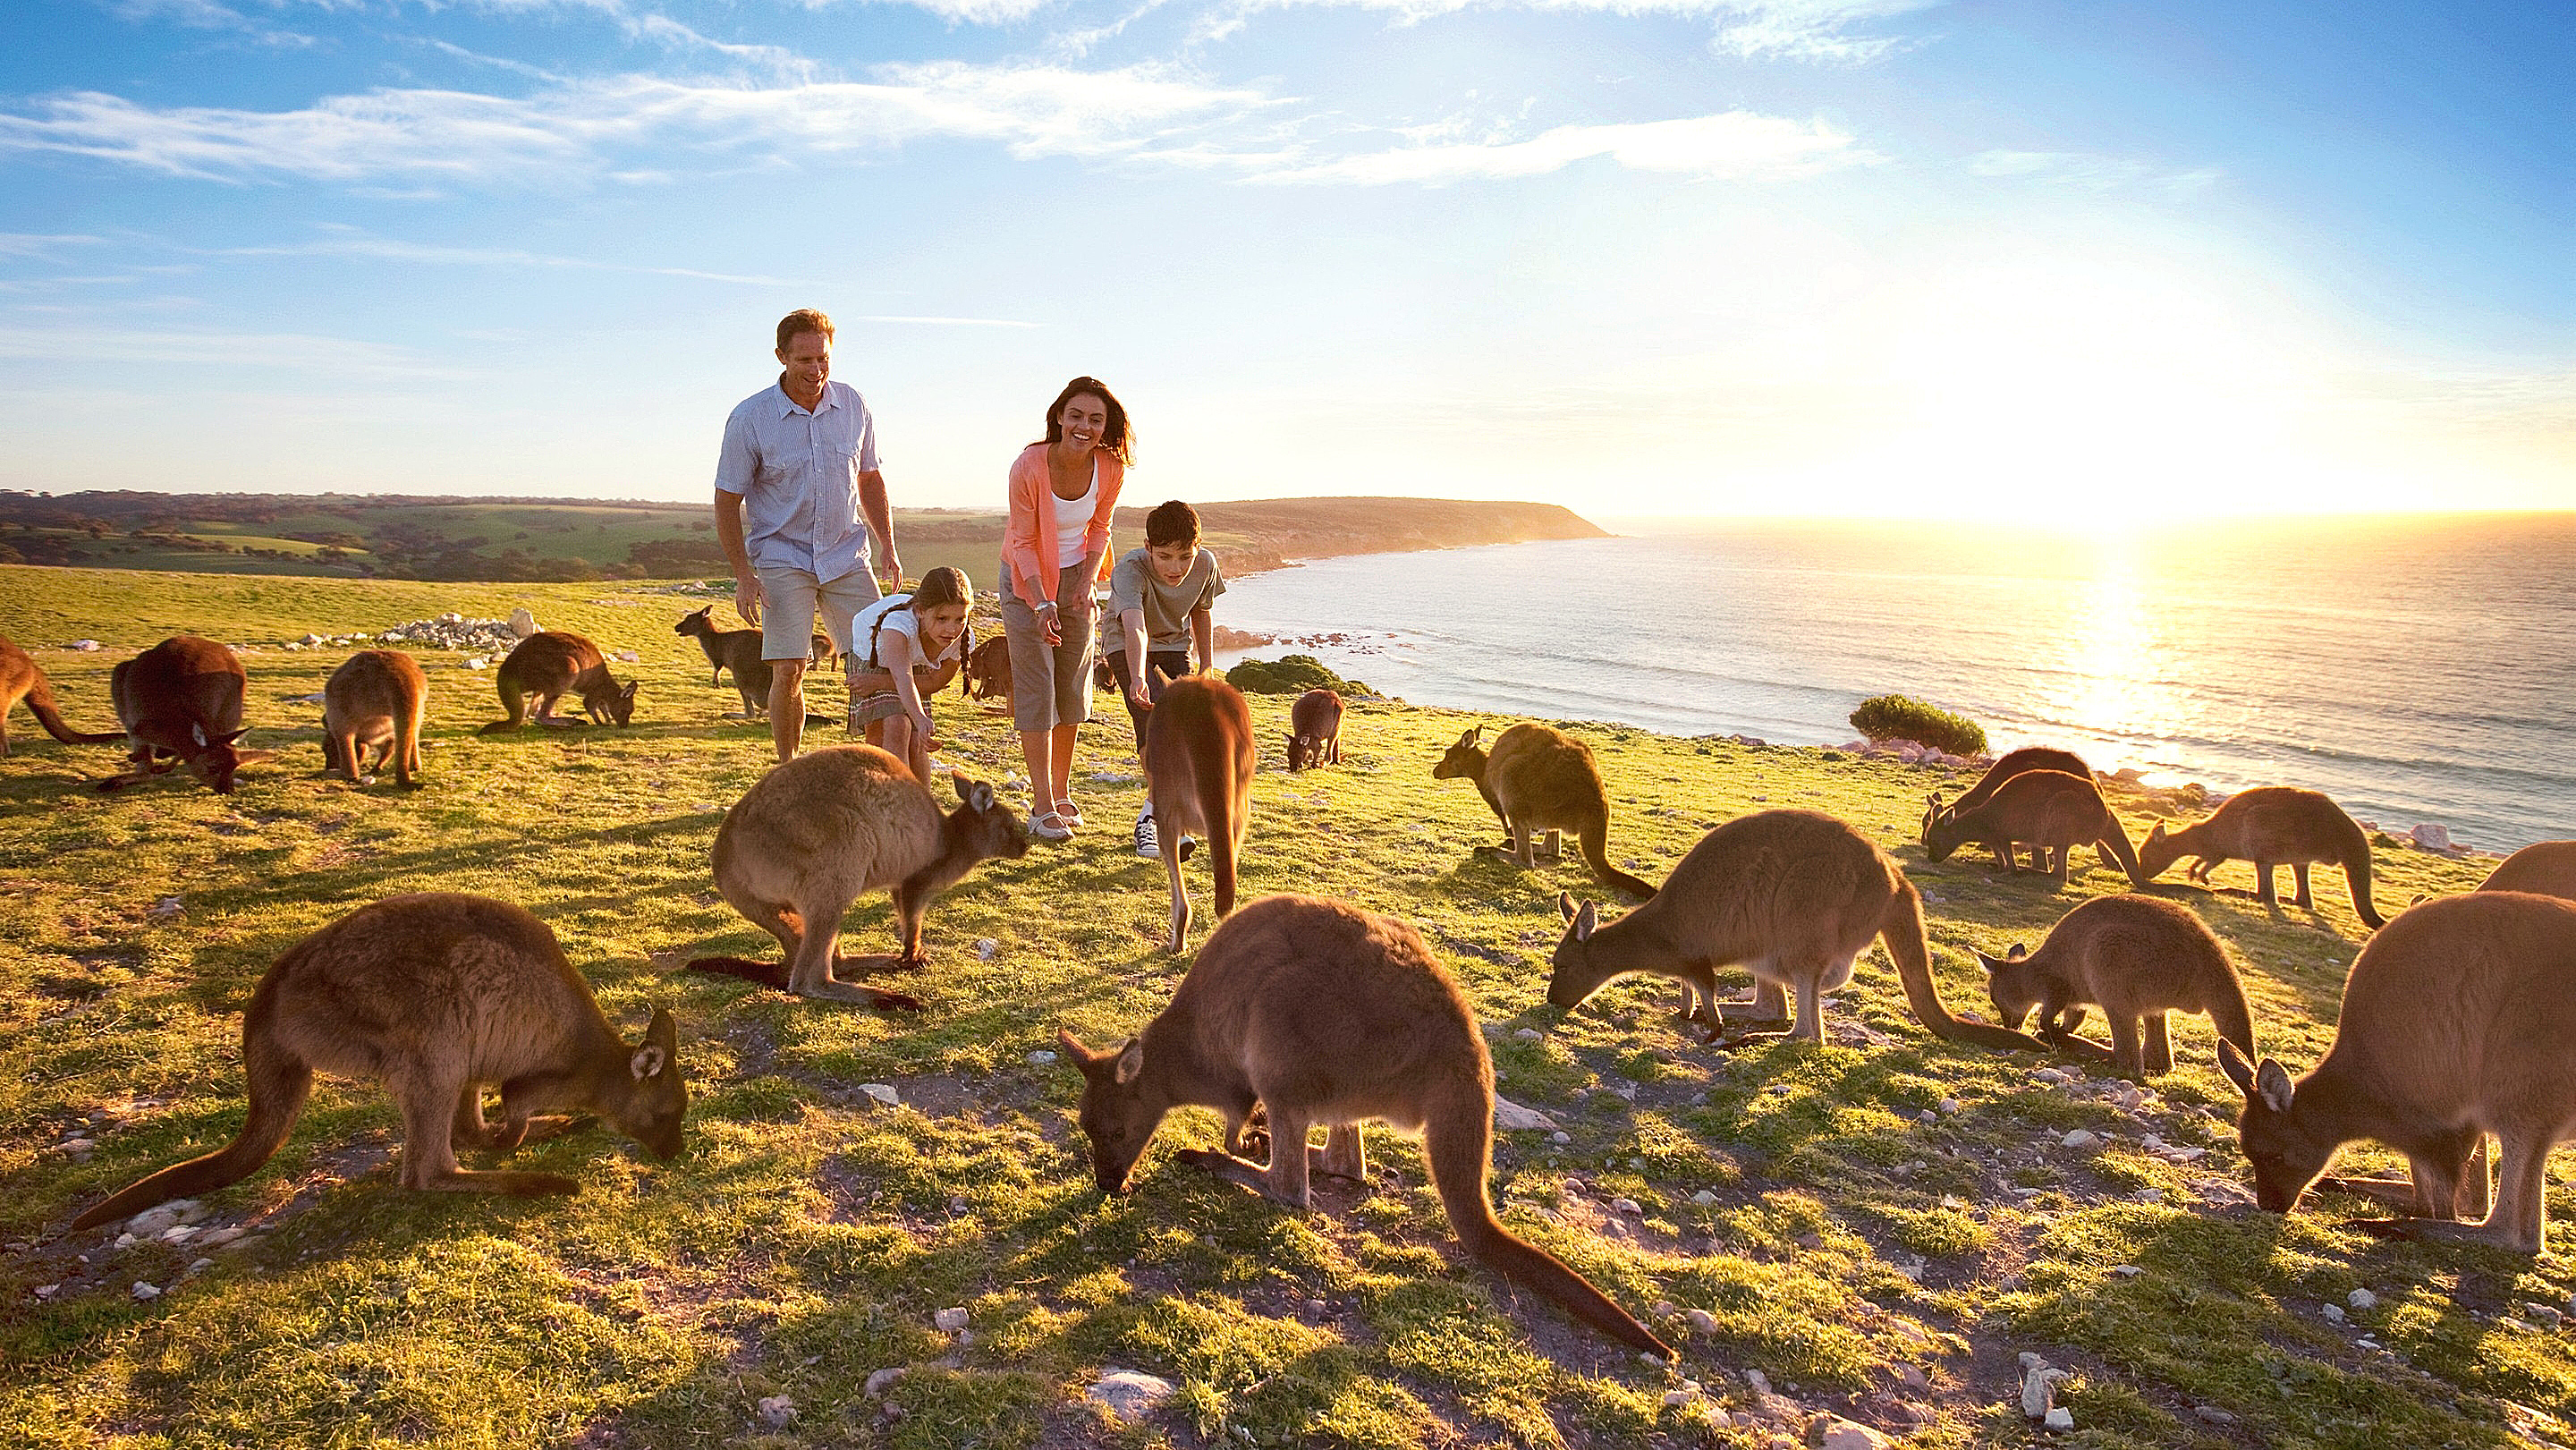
(716, 307), (904, 759)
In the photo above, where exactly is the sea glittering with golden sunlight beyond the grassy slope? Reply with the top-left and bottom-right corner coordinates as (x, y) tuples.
(1216, 515), (2576, 852)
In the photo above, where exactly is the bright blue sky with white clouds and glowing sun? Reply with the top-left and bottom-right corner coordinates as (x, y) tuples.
(0, 0), (2576, 522)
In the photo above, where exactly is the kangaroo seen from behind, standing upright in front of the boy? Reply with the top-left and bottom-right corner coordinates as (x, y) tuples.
(1144, 674), (1259, 953)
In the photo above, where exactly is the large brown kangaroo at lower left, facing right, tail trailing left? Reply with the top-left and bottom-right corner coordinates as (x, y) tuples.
(72, 891), (688, 1228)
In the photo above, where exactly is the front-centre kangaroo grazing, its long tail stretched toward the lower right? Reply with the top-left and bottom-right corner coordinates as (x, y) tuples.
(1056, 895), (1672, 1360)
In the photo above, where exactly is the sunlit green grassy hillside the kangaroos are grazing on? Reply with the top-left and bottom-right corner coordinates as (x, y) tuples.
(0, 569), (2576, 1450)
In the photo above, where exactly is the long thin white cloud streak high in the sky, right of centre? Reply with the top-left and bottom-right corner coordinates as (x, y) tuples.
(1252, 111), (1885, 185)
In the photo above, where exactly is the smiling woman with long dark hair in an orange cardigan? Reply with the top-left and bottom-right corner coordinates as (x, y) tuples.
(1002, 378), (1133, 840)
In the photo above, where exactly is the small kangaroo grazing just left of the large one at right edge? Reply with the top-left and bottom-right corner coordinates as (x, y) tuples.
(1976, 896), (2254, 1074)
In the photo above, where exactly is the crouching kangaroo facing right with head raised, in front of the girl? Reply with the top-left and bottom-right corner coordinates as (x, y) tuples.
(688, 744), (1028, 1010)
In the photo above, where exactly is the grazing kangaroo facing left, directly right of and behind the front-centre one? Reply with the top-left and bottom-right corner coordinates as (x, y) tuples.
(1548, 811), (2048, 1051)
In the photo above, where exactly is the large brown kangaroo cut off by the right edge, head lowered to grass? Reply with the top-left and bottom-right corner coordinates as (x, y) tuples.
(2218, 891), (2576, 1254)
